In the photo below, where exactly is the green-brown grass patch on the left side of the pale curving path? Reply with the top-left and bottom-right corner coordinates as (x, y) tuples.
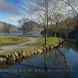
(0, 36), (27, 46)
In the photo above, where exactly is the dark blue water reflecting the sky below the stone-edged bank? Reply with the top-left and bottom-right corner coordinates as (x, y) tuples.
(0, 40), (78, 78)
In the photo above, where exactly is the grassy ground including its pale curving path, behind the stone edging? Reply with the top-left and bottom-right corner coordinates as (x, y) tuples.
(0, 36), (62, 54)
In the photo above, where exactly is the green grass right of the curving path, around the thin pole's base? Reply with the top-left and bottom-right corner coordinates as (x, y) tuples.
(31, 37), (62, 47)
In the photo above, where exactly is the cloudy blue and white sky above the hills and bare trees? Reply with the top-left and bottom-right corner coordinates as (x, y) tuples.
(0, 0), (78, 26)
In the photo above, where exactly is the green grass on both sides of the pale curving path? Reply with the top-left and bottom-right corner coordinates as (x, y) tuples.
(0, 36), (62, 46)
